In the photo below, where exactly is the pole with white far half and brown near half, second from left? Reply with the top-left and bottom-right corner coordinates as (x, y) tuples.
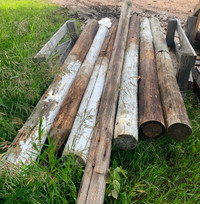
(49, 25), (108, 153)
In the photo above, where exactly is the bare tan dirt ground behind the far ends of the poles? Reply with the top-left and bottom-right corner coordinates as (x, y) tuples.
(51, 0), (199, 21)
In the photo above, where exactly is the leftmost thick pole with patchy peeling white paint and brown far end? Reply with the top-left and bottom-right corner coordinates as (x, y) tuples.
(0, 20), (98, 165)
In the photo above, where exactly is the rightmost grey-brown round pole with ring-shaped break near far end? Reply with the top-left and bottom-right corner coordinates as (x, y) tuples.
(150, 18), (192, 140)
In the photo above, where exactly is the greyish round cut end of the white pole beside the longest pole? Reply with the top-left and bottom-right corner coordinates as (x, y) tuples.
(115, 135), (138, 150)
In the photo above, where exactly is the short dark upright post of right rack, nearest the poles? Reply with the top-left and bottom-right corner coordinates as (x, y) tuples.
(166, 19), (177, 47)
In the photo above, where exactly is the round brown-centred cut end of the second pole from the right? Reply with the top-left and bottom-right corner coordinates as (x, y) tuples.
(140, 121), (165, 139)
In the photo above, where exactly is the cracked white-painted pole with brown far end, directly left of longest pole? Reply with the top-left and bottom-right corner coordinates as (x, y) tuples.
(62, 23), (117, 165)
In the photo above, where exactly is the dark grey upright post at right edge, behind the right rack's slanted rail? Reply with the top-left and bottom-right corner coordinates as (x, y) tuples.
(185, 16), (197, 42)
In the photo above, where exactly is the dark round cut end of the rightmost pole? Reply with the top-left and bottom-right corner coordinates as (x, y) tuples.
(168, 123), (192, 141)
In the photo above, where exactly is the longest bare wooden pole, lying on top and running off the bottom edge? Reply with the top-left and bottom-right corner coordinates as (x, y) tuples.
(77, 0), (132, 204)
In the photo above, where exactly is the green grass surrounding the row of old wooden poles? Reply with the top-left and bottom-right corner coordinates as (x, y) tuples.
(0, 0), (200, 204)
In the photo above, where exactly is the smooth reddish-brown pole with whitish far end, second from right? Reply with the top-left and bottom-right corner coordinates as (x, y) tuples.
(139, 18), (165, 138)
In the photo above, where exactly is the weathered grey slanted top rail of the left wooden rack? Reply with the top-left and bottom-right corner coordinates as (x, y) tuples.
(33, 21), (68, 62)
